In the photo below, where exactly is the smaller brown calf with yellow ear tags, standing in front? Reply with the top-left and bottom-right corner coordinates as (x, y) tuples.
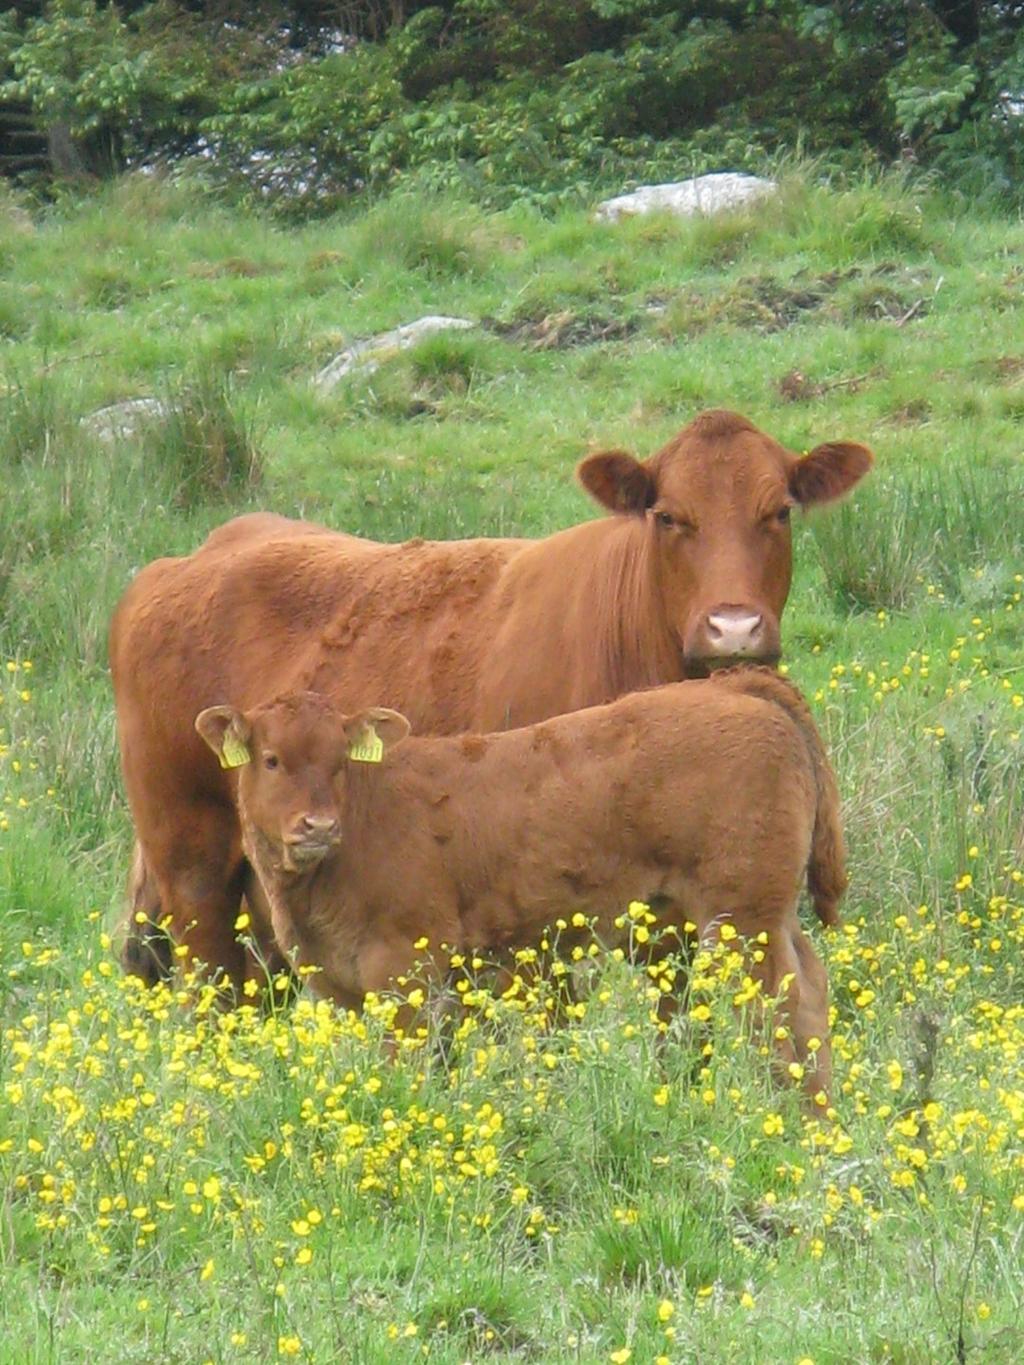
(195, 669), (847, 1092)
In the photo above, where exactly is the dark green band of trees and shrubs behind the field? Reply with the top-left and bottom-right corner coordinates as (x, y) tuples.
(0, 0), (1024, 210)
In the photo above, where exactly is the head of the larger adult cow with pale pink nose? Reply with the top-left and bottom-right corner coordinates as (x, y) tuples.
(578, 411), (872, 677)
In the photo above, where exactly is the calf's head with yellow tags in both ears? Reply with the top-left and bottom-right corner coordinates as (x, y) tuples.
(195, 692), (410, 872)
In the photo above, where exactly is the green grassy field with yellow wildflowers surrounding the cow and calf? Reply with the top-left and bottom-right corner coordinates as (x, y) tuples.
(0, 168), (1024, 1365)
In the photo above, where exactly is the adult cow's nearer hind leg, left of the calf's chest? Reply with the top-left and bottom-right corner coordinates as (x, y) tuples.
(142, 803), (247, 987)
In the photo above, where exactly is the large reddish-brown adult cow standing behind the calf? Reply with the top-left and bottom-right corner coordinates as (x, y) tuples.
(111, 412), (871, 981)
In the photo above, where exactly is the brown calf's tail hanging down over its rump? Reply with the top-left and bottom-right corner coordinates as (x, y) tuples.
(711, 666), (849, 924)
